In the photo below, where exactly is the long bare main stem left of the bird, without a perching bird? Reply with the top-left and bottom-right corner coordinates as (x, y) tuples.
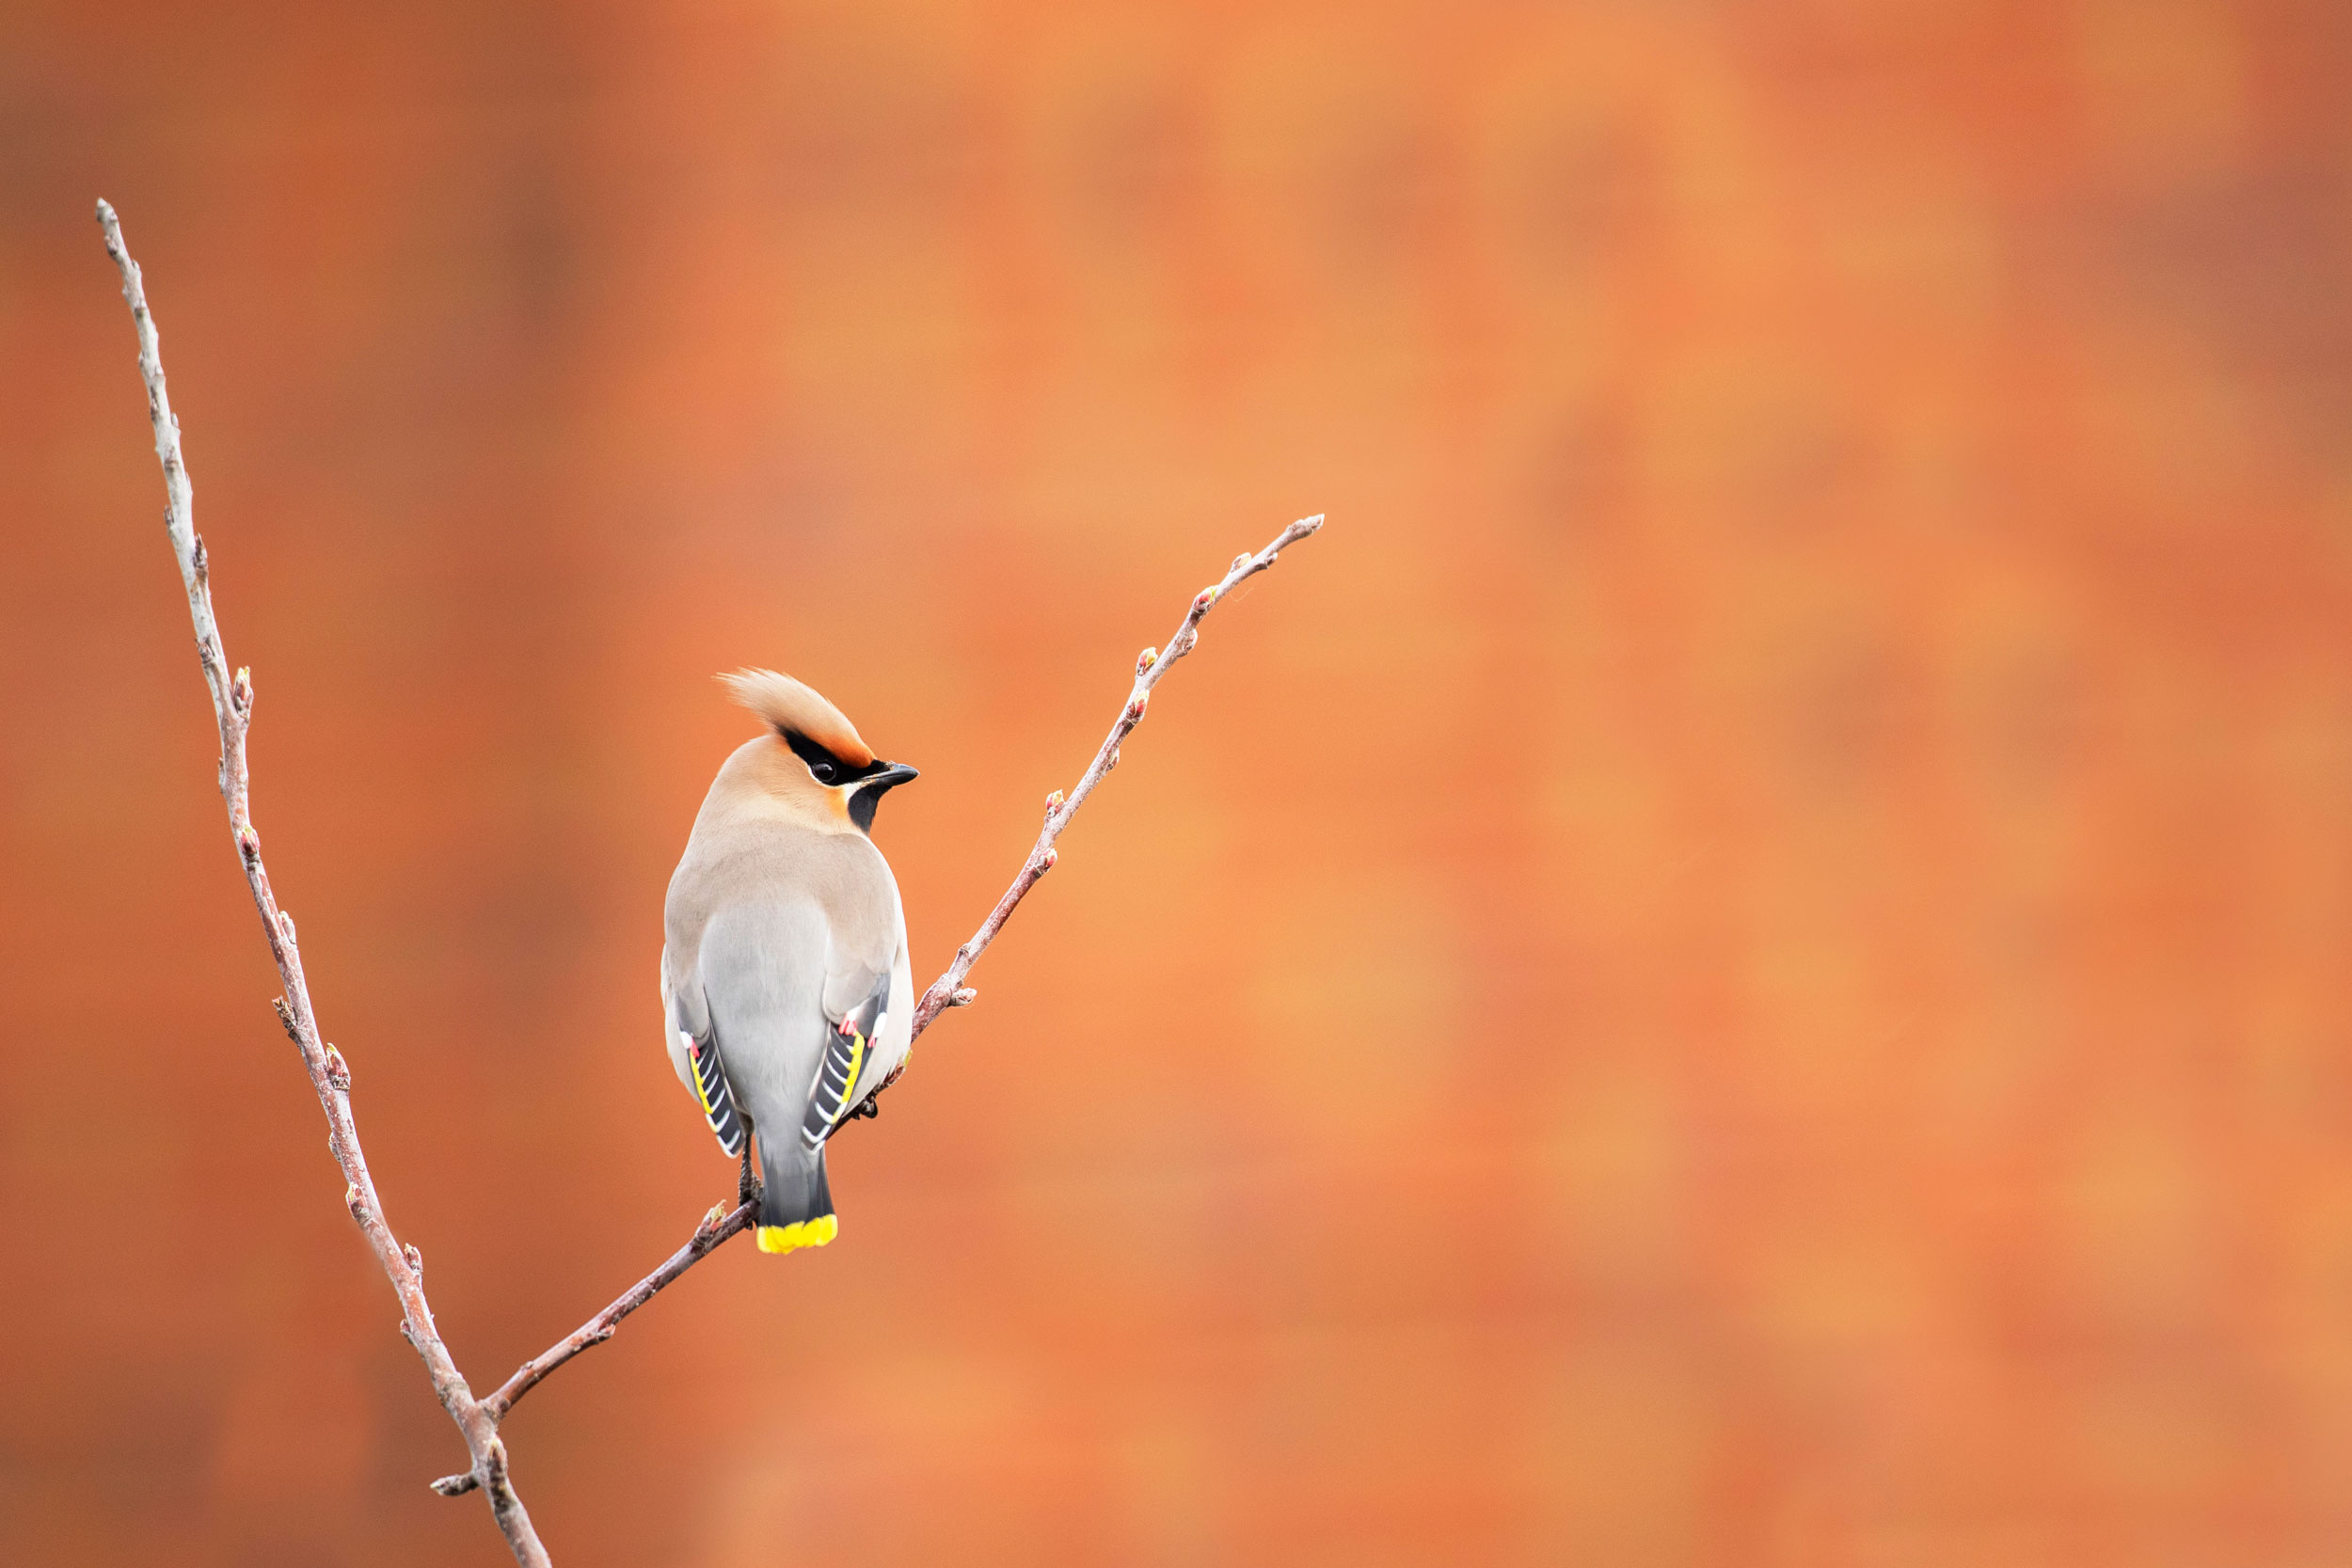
(99, 202), (548, 1568)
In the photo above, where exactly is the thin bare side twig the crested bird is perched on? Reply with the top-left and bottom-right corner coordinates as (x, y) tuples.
(463, 513), (1322, 1438)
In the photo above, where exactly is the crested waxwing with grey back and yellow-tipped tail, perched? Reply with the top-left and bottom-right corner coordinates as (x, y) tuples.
(661, 670), (915, 1253)
